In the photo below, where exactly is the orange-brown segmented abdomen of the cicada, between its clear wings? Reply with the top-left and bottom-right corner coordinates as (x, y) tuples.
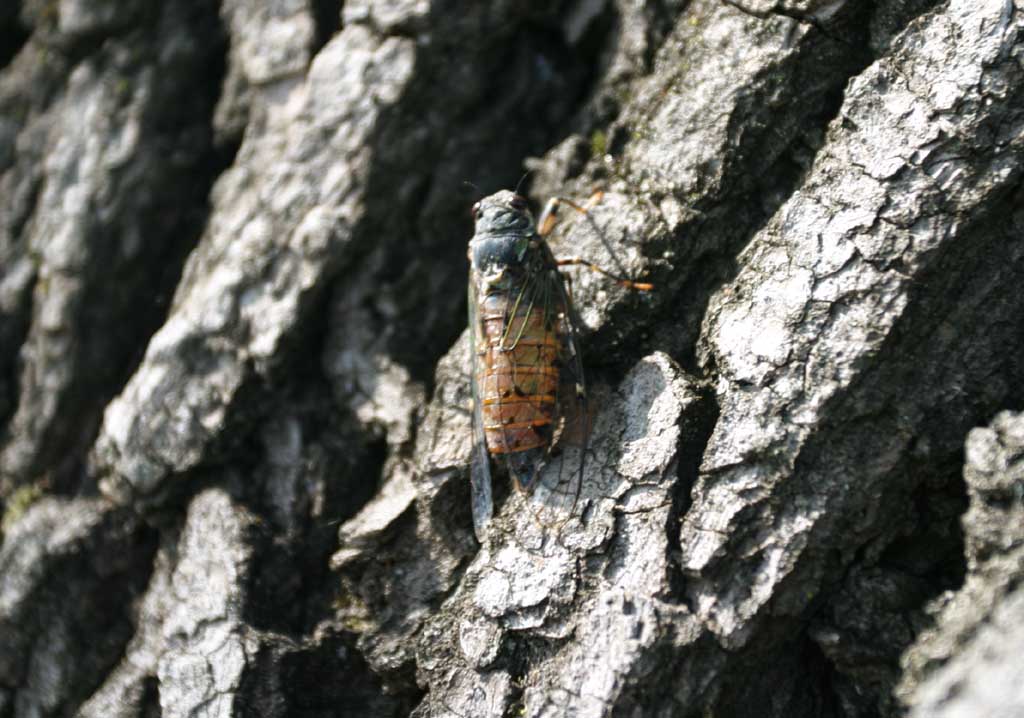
(477, 294), (559, 454)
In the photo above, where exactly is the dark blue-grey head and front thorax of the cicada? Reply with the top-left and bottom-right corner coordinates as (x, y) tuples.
(469, 189), (535, 271)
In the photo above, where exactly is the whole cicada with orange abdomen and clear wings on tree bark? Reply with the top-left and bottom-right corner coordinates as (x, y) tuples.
(469, 191), (651, 541)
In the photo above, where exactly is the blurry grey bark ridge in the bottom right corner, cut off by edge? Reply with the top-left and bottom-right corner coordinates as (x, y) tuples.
(899, 412), (1024, 717)
